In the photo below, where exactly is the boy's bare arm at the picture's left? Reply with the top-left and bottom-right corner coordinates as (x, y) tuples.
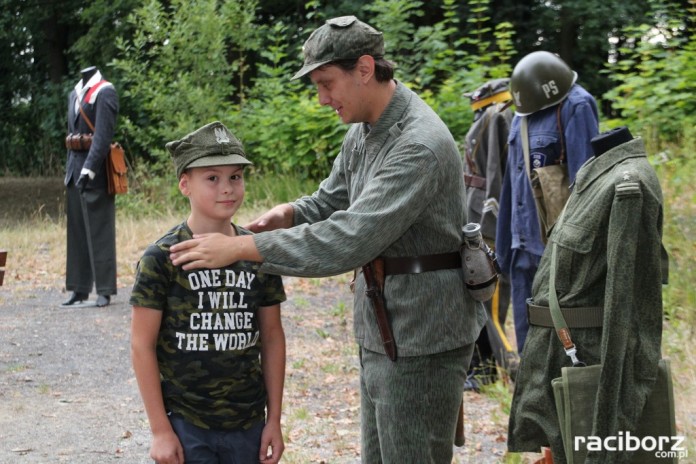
(131, 306), (184, 464)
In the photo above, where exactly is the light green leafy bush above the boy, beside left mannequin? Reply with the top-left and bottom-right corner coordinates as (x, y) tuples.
(113, 0), (258, 175)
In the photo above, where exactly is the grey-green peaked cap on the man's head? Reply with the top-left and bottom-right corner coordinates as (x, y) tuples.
(292, 16), (384, 79)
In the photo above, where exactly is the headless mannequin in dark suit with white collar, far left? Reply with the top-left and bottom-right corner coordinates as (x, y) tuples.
(61, 66), (118, 307)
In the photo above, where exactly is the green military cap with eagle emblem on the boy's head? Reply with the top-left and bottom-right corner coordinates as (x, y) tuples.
(165, 121), (253, 178)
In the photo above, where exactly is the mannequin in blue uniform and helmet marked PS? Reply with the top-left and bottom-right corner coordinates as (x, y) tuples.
(495, 51), (599, 352)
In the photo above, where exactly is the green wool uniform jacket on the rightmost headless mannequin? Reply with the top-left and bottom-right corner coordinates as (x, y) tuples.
(508, 139), (667, 464)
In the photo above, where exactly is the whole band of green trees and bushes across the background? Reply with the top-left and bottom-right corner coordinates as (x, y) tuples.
(0, 0), (696, 181)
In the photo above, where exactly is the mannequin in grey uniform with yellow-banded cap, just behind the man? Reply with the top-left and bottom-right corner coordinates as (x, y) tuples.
(464, 78), (518, 391)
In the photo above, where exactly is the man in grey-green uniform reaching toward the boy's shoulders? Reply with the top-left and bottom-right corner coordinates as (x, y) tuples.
(170, 16), (486, 464)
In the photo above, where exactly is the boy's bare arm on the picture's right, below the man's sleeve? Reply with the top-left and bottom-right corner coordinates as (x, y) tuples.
(258, 304), (285, 463)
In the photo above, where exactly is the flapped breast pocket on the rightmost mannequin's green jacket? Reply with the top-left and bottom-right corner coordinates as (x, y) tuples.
(551, 222), (598, 294)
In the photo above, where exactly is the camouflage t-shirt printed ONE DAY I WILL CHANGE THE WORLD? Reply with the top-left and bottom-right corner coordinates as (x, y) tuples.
(130, 222), (286, 430)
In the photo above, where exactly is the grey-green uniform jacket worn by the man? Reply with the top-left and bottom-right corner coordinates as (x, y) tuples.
(254, 83), (486, 356)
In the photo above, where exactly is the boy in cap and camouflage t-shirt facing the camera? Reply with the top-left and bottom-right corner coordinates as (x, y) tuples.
(130, 122), (285, 463)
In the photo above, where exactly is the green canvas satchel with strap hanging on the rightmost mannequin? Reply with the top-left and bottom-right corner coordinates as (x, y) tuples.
(549, 214), (678, 464)
